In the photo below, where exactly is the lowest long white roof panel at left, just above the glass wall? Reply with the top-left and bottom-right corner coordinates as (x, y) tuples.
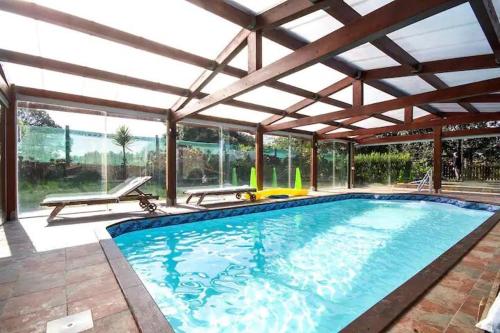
(2, 63), (178, 108)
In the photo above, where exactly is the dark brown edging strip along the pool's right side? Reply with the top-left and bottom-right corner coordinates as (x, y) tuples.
(341, 211), (500, 333)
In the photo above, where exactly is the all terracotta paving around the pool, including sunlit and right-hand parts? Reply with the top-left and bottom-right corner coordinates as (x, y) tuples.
(0, 188), (500, 333)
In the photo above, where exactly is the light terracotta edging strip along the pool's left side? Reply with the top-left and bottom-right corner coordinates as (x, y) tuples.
(99, 239), (174, 333)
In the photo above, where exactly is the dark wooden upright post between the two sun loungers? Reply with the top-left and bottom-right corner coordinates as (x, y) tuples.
(165, 113), (177, 207)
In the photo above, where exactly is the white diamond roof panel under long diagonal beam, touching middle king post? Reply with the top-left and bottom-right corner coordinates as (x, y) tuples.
(280, 64), (346, 92)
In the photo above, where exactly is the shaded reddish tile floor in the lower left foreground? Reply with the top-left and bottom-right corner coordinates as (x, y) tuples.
(0, 223), (138, 333)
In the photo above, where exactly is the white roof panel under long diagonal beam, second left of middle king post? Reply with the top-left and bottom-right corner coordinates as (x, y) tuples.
(236, 87), (303, 109)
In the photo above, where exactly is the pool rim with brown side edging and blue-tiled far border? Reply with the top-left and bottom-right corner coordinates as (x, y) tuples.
(98, 192), (500, 333)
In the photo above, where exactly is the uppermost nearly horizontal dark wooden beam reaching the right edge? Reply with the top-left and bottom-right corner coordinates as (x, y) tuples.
(362, 54), (498, 81)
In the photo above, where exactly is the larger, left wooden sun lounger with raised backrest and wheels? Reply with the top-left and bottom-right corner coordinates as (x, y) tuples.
(40, 176), (158, 222)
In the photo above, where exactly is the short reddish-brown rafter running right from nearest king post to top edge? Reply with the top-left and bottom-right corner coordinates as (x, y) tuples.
(255, 0), (338, 30)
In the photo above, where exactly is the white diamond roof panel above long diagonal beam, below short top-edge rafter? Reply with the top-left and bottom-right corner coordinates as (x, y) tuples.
(282, 10), (343, 42)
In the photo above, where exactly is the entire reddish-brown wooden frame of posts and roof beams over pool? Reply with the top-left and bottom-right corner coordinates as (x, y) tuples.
(0, 0), (500, 218)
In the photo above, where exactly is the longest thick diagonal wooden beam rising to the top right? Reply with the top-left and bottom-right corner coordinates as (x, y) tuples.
(176, 0), (463, 120)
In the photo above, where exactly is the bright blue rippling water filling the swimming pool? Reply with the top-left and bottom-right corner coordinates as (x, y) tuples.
(115, 199), (493, 333)
